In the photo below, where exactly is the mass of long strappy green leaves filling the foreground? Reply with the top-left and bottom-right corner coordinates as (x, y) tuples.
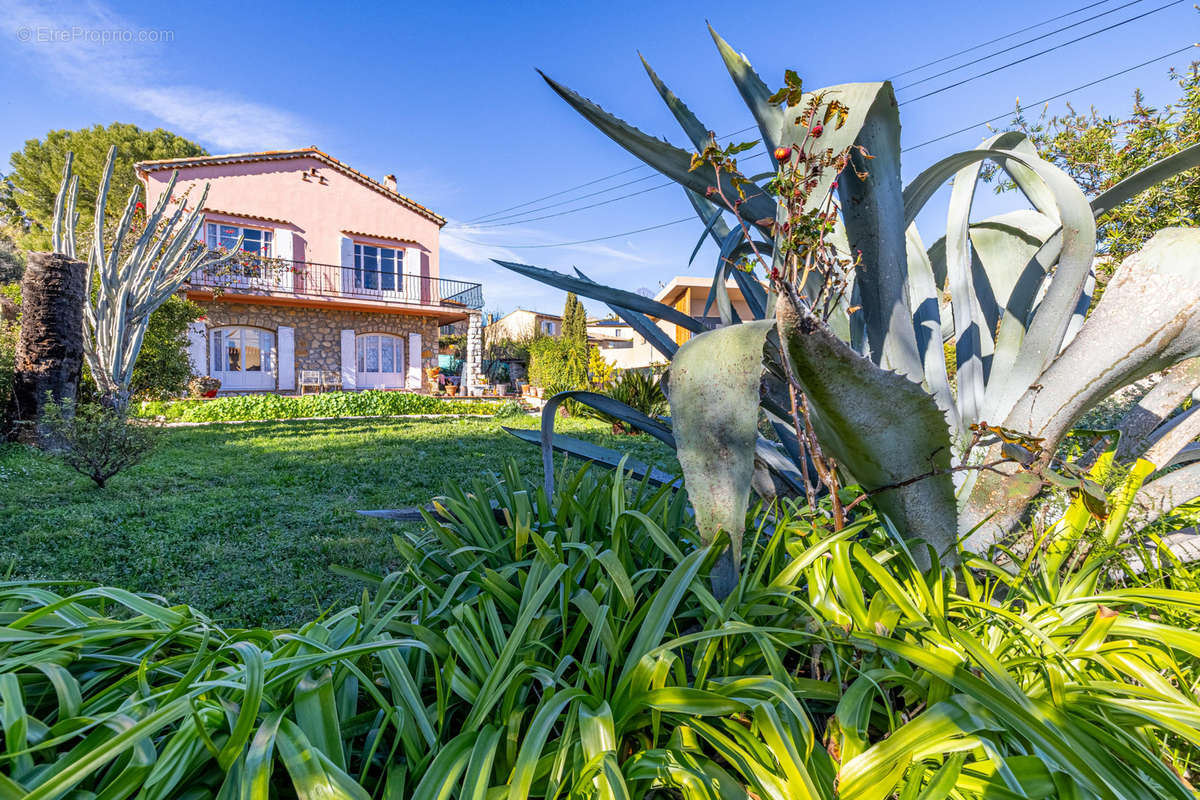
(14, 465), (1200, 800)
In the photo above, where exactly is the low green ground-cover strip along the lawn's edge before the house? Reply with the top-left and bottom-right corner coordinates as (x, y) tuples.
(137, 390), (502, 422)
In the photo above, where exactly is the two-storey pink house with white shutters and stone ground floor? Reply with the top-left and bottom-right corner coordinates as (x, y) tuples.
(137, 148), (482, 392)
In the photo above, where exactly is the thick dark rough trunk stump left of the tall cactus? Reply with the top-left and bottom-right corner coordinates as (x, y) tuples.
(5, 253), (88, 440)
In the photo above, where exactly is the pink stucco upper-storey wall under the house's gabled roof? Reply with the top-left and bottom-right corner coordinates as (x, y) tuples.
(145, 157), (439, 278)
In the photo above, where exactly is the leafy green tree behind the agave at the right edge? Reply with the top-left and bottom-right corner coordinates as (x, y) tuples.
(1001, 62), (1200, 279)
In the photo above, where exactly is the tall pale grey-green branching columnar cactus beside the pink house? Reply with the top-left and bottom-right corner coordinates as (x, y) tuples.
(53, 146), (240, 411)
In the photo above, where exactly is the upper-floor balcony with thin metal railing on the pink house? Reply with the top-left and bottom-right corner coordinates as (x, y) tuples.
(187, 258), (484, 312)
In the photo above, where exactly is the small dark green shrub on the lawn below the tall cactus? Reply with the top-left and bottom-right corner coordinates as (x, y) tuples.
(40, 401), (158, 488)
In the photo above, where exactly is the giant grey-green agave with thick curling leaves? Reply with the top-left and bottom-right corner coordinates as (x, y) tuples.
(498, 32), (1200, 563)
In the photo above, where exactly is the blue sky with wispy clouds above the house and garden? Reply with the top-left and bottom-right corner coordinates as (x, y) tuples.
(0, 0), (1200, 312)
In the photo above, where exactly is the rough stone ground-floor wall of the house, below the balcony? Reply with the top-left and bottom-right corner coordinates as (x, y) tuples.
(197, 300), (439, 391)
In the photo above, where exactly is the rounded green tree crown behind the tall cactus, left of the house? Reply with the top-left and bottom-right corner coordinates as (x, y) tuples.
(0, 122), (208, 249)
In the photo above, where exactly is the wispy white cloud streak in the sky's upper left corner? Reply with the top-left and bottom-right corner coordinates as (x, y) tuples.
(0, 0), (316, 151)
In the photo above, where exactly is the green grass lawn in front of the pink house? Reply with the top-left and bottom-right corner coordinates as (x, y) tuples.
(0, 417), (677, 626)
